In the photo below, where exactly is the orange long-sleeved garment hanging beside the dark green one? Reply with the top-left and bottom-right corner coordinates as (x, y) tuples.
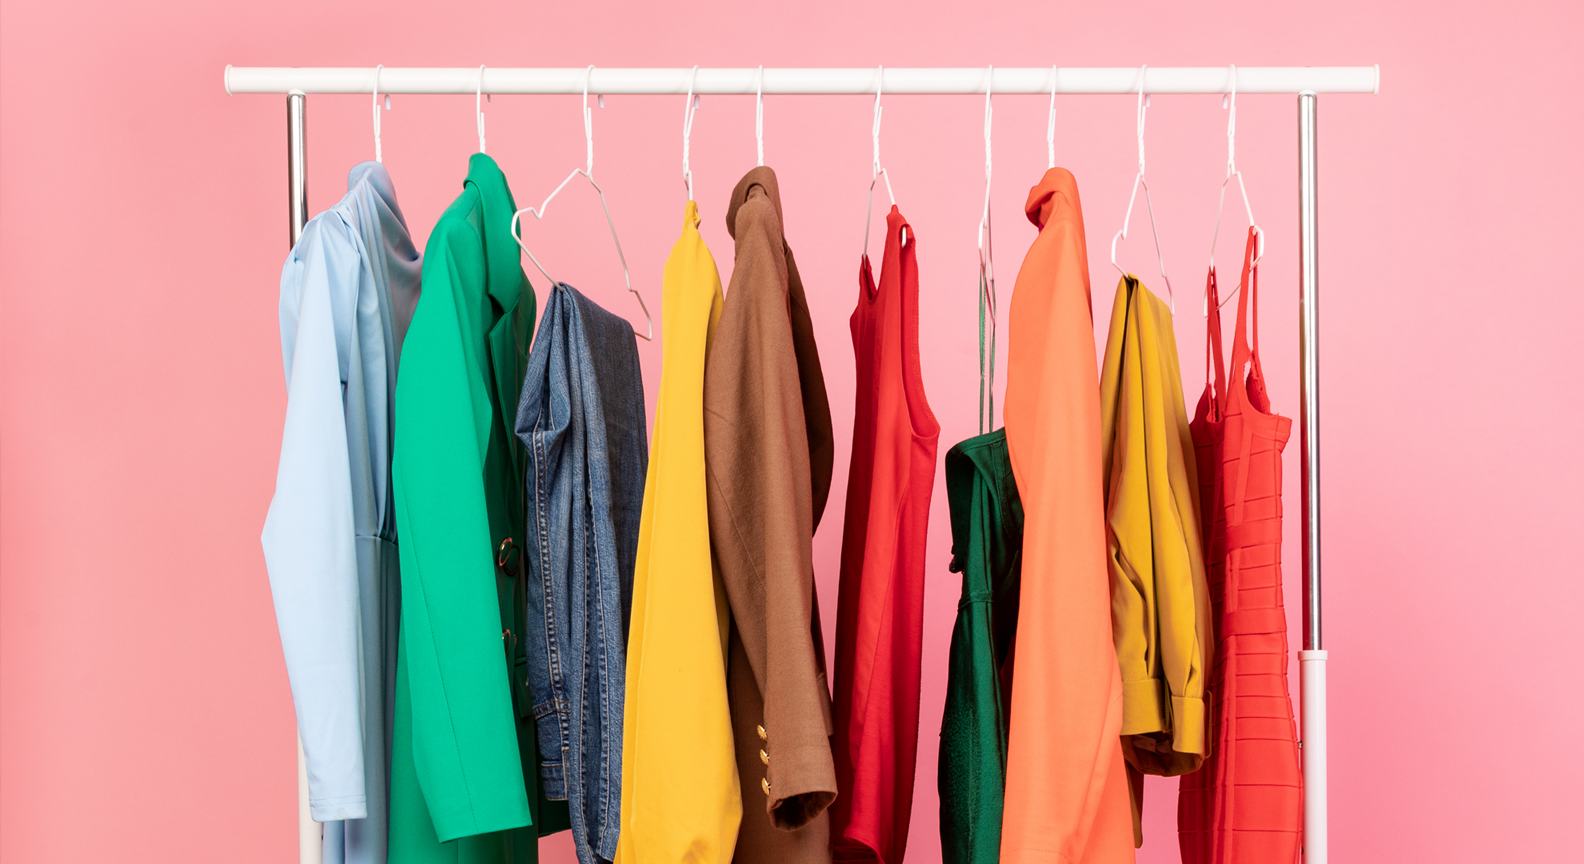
(1001, 168), (1134, 864)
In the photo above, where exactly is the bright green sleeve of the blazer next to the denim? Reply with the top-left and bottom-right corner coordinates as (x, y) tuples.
(393, 187), (531, 843)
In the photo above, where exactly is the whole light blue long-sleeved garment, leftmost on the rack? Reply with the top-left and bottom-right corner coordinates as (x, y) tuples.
(263, 162), (423, 864)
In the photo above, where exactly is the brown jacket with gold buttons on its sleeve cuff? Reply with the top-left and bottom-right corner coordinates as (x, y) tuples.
(703, 168), (836, 864)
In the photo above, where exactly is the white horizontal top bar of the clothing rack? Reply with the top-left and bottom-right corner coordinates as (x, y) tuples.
(225, 67), (1380, 95)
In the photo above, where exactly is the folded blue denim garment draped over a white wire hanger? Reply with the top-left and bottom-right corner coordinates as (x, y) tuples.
(516, 282), (649, 864)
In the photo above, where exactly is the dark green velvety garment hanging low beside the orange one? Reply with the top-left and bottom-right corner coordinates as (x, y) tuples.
(938, 430), (1023, 864)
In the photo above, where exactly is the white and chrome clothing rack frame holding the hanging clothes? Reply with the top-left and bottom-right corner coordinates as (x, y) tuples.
(225, 65), (1380, 864)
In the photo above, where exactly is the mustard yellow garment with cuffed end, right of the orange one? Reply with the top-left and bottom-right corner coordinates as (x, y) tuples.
(1101, 276), (1213, 777)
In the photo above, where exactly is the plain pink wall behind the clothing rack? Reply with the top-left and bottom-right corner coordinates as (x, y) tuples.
(0, 0), (1584, 864)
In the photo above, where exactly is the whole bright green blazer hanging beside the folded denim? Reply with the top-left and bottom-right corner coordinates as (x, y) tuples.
(390, 154), (567, 864)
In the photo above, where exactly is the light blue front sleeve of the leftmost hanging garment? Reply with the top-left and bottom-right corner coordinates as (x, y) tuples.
(261, 214), (367, 821)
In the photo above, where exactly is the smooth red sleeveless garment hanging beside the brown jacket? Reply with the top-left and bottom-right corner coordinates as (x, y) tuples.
(832, 205), (941, 864)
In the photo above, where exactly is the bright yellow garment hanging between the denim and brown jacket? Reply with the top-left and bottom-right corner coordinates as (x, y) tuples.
(616, 201), (743, 864)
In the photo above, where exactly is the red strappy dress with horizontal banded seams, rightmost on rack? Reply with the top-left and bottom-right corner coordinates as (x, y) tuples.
(1177, 230), (1304, 864)
